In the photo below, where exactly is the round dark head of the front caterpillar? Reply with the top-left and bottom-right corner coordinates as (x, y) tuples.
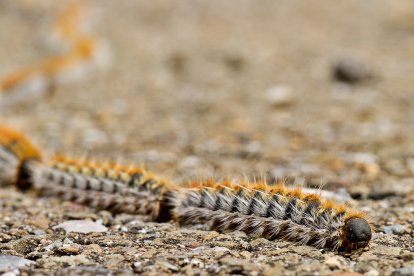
(341, 217), (372, 251)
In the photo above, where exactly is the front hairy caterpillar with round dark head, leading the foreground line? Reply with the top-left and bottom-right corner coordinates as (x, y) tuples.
(172, 181), (372, 251)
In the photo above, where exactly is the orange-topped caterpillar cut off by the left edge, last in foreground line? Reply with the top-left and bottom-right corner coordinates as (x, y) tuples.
(0, 125), (42, 189)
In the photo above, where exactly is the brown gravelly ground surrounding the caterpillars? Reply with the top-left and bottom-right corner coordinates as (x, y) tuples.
(0, 0), (414, 275)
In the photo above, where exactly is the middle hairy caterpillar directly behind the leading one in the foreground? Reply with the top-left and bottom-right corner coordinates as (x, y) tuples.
(32, 156), (172, 220)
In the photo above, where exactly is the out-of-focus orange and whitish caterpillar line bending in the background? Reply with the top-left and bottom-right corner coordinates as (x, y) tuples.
(0, 3), (109, 106)
